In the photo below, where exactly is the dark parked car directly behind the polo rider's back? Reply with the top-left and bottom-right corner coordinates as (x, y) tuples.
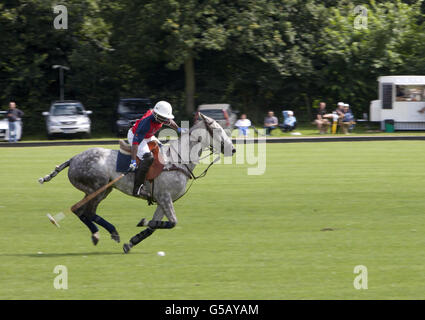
(115, 98), (152, 136)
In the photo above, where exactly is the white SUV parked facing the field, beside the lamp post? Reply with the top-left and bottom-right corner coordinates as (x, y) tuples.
(43, 101), (92, 138)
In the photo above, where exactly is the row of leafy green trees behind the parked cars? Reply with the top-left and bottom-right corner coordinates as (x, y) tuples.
(0, 0), (425, 131)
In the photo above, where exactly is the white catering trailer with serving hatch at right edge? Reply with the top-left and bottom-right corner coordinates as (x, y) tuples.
(370, 76), (425, 130)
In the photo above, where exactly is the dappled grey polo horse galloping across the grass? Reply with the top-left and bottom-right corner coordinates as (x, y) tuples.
(40, 114), (235, 253)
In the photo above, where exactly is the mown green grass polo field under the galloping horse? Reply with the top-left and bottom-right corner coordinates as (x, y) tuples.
(0, 141), (425, 299)
